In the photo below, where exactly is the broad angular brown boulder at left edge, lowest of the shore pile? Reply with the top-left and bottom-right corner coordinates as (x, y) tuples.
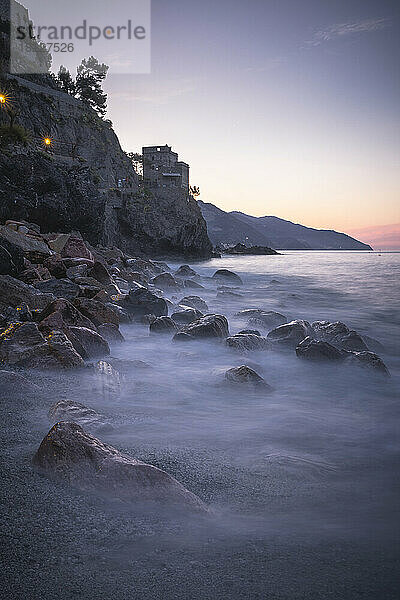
(0, 323), (83, 369)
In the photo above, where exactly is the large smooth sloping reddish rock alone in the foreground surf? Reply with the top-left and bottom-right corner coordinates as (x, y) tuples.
(33, 422), (207, 513)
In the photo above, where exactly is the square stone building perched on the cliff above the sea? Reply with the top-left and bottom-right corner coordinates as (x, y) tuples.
(142, 145), (189, 193)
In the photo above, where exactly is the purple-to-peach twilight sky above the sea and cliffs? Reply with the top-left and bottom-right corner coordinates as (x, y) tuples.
(24, 0), (400, 247)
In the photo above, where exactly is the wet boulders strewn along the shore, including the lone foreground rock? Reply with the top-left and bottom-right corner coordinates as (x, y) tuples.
(0, 221), (389, 513)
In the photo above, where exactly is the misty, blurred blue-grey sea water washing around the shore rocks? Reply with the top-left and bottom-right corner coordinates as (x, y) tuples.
(0, 252), (400, 600)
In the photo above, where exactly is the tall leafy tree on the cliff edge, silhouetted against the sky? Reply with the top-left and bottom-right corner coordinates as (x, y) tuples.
(75, 56), (108, 117)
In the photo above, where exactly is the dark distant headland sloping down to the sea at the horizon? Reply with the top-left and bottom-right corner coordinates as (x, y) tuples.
(199, 201), (372, 250)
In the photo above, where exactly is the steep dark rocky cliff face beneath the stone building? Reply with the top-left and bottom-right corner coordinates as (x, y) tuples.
(0, 75), (212, 257)
